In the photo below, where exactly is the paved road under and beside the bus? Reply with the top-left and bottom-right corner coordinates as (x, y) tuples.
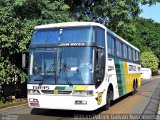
(0, 79), (160, 120)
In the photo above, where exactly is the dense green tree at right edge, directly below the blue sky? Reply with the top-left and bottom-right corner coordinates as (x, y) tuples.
(128, 18), (160, 63)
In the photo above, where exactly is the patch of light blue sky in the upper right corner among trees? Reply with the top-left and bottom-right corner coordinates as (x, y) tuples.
(140, 3), (160, 23)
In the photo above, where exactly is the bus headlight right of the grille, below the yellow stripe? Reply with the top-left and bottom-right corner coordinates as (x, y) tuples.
(72, 90), (93, 96)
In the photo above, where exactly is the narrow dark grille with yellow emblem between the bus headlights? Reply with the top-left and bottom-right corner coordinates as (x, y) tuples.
(41, 90), (72, 94)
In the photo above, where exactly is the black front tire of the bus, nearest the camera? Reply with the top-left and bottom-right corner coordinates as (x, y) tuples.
(104, 89), (113, 111)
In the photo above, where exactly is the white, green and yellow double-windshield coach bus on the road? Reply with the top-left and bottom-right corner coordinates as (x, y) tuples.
(24, 22), (141, 111)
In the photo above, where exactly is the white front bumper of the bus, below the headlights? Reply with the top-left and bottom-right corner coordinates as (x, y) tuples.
(28, 95), (103, 111)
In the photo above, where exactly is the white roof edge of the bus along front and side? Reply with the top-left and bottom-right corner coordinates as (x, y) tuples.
(34, 22), (139, 51)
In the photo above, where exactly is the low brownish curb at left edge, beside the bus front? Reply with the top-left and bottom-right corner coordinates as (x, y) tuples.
(0, 100), (27, 110)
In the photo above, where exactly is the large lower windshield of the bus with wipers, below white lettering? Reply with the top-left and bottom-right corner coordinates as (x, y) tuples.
(29, 47), (94, 85)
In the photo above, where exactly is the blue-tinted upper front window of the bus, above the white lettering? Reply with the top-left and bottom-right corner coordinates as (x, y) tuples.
(31, 27), (94, 45)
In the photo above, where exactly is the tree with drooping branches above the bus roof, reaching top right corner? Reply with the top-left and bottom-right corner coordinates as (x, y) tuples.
(66, 0), (160, 38)
